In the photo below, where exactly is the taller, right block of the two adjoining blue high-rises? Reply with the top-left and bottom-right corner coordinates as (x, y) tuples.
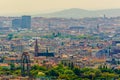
(21, 16), (31, 28)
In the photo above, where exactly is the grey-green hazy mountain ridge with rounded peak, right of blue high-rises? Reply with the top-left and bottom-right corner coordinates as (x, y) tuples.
(34, 8), (120, 18)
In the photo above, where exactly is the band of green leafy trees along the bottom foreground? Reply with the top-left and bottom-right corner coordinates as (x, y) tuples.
(0, 63), (120, 80)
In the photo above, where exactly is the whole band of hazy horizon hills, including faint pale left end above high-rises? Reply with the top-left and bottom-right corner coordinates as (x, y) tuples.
(1, 8), (120, 19)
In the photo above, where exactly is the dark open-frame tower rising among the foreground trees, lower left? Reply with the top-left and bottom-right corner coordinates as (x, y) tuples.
(21, 52), (30, 77)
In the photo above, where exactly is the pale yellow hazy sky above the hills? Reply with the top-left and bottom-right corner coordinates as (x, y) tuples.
(0, 0), (120, 14)
